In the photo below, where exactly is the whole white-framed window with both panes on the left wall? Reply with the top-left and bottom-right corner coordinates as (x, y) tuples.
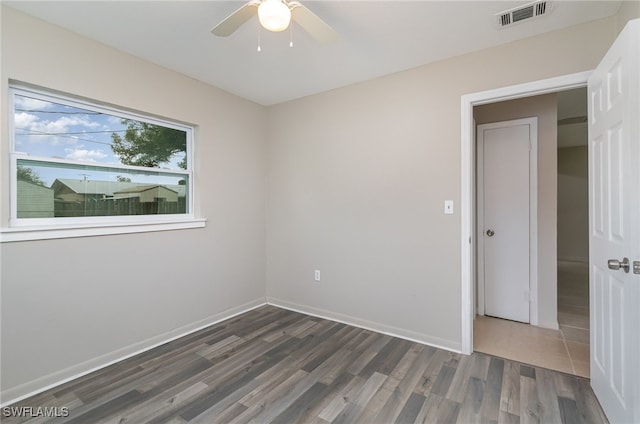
(3, 87), (202, 239)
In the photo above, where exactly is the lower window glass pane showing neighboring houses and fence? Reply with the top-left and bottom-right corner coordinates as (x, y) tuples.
(16, 159), (189, 218)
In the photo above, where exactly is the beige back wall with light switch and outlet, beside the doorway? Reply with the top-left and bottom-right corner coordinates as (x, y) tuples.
(267, 18), (615, 349)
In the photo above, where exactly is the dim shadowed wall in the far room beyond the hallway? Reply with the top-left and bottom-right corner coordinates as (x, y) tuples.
(558, 146), (589, 263)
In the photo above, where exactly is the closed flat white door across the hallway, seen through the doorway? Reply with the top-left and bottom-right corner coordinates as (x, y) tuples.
(478, 118), (537, 323)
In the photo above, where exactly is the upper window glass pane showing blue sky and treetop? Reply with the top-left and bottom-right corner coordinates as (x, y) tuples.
(14, 93), (187, 170)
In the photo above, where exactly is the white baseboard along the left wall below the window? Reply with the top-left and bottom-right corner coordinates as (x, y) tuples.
(0, 299), (266, 407)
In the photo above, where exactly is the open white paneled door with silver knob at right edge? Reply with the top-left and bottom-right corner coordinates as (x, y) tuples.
(588, 19), (640, 423)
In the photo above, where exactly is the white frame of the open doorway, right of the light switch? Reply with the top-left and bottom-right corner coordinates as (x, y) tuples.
(460, 71), (592, 355)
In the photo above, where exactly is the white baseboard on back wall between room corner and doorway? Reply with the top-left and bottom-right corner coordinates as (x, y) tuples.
(267, 297), (461, 353)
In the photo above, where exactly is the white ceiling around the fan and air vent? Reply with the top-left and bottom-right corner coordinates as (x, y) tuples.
(3, 0), (621, 105)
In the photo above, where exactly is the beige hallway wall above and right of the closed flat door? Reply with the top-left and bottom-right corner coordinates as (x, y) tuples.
(474, 94), (558, 328)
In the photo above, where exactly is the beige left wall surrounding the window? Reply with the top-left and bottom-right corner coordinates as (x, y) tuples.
(0, 6), (266, 402)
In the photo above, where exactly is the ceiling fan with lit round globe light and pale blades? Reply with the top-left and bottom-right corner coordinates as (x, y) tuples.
(211, 0), (338, 44)
